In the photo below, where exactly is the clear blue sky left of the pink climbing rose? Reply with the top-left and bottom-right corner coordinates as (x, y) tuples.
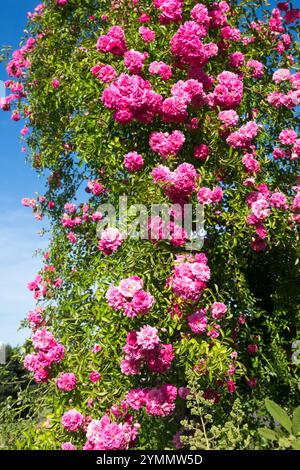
(0, 0), (46, 345)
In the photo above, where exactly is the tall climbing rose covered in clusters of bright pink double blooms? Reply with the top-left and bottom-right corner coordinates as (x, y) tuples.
(1, 0), (300, 450)
